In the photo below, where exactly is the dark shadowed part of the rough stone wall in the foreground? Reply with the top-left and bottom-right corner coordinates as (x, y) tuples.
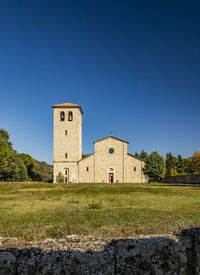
(0, 228), (200, 275)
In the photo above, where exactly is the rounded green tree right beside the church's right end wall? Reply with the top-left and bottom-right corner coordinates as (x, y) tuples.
(143, 151), (166, 181)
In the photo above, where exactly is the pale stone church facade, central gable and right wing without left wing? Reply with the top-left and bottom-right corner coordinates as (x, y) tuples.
(93, 136), (147, 183)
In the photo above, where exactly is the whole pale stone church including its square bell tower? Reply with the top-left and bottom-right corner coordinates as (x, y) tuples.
(52, 103), (147, 183)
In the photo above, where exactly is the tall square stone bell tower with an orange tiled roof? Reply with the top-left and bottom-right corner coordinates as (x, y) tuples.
(52, 103), (83, 182)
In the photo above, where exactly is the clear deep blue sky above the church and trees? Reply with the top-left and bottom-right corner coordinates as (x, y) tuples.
(0, 0), (200, 163)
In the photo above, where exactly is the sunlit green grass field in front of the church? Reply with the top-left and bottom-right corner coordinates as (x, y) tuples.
(0, 183), (200, 240)
